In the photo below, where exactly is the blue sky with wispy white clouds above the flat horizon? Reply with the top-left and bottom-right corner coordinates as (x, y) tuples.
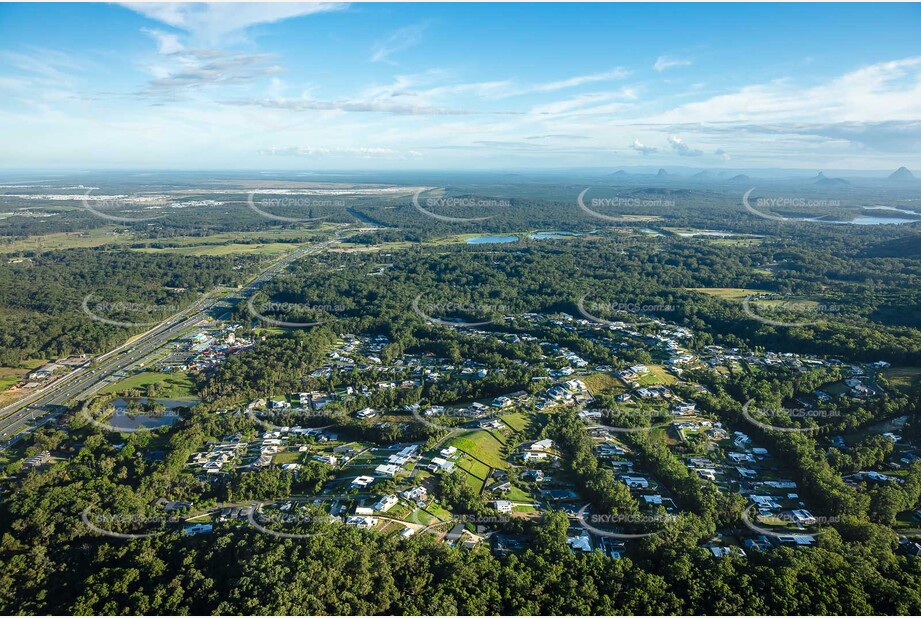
(0, 3), (921, 171)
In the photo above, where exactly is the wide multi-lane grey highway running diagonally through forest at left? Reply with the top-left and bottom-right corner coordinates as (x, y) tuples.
(0, 239), (338, 451)
